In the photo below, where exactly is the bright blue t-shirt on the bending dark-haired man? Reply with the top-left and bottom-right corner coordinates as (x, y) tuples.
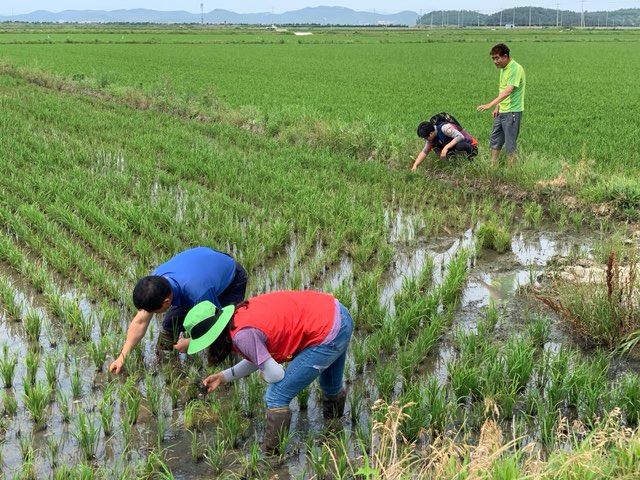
(151, 247), (236, 308)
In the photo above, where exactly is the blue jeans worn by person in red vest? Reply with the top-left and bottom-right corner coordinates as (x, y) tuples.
(266, 304), (353, 408)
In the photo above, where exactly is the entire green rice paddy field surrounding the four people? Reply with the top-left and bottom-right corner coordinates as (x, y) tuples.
(0, 25), (640, 479)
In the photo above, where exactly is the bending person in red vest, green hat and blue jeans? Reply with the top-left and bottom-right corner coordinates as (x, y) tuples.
(184, 291), (353, 453)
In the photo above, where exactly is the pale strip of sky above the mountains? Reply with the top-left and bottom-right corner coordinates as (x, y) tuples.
(0, 0), (640, 15)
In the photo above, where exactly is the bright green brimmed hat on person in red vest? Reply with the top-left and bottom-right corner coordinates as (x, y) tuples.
(184, 300), (235, 354)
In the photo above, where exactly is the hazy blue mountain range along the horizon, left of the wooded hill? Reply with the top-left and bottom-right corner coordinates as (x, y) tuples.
(0, 7), (418, 25)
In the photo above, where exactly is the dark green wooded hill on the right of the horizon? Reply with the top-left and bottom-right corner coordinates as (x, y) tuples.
(418, 7), (640, 27)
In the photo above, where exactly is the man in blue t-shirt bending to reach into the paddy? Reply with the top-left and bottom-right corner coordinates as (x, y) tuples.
(109, 247), (247, 373)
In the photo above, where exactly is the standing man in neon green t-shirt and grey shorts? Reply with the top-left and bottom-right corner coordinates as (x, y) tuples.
(477, 43), (526, 166)
